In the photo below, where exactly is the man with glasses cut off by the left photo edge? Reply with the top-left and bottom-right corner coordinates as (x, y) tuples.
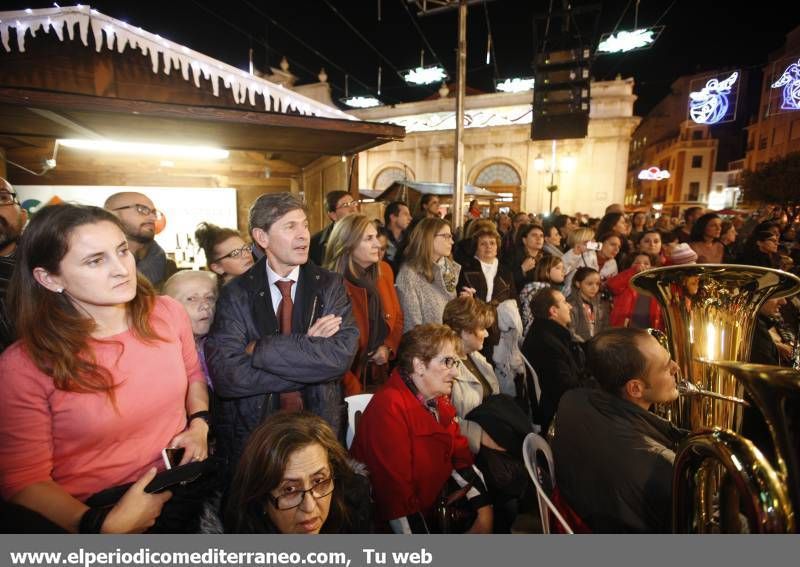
(0, 177), (28, 352)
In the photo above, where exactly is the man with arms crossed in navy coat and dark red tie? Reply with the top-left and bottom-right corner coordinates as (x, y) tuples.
(206, 193), (358, 478)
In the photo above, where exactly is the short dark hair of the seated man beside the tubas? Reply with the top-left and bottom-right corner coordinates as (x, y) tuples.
(586, 327), (649, 395)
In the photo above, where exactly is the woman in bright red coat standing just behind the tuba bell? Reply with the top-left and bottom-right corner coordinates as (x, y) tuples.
(606, 252), (664, 329)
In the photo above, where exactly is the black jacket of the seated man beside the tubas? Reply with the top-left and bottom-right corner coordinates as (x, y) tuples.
(553, 388), (688, 533)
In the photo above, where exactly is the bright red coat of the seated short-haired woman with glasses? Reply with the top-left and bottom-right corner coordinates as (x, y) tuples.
(350, 369), (473, 522)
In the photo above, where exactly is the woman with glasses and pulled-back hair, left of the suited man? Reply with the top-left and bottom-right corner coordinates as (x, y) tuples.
(194, 222), (253, 285)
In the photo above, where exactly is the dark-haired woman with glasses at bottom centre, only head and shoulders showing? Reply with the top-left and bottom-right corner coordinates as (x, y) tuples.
(224, 411), (371, 534)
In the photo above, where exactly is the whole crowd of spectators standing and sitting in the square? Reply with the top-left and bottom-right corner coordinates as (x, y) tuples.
(0, 180), (800, 533)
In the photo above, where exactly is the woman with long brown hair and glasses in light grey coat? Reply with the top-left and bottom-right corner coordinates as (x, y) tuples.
(397, 218), (461, 331)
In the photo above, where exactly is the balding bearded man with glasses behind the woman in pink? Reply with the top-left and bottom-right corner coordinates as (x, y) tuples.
(103, 191), (167, 287)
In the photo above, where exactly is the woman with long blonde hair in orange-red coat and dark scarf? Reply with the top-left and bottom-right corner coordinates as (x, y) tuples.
(325, 214), (403, 396)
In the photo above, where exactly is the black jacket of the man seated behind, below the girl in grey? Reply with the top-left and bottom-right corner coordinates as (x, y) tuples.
(522, 319), (585, 431)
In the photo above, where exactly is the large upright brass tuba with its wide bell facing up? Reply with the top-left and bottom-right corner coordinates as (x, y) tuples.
(631, 264), (800, 431)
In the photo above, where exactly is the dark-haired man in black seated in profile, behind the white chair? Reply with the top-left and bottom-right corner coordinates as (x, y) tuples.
(522, 287), (584, 431)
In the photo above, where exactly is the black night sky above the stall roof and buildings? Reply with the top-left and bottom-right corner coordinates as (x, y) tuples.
(0, 0), (800, 115)
